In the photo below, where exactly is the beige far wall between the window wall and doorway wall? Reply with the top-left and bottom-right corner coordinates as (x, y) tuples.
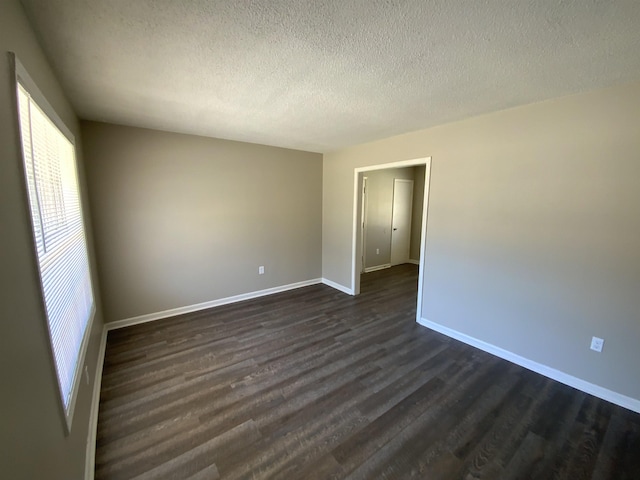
(82, 122), (322, 321)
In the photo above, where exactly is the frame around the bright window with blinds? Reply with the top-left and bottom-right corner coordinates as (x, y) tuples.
(10, 53), (96, 435)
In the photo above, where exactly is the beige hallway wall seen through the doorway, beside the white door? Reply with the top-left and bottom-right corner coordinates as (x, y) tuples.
(363, 167), (414, 268)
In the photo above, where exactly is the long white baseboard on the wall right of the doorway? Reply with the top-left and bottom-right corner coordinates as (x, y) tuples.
(418, 318), (640, 413)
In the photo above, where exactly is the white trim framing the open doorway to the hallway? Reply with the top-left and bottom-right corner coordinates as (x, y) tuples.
(351, 157), (431, 319)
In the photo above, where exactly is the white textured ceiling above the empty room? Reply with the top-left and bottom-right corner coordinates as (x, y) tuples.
(22, 0), (640, 152)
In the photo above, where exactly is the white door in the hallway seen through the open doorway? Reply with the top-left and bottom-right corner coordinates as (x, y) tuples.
(391, 178), (413, 265)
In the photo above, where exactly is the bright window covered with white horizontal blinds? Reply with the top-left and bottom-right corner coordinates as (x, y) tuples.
(16, 61), (95, 431)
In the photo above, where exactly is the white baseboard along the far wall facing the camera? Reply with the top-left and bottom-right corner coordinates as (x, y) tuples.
(105, 278), (322, 330)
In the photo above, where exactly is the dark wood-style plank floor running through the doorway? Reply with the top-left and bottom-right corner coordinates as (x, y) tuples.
(96, 265), (640, 480)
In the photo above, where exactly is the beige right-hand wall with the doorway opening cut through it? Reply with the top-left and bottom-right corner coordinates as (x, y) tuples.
(323, 84), (640, 399)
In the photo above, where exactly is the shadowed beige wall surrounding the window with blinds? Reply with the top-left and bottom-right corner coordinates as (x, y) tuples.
(0, 0), (102, 480)
